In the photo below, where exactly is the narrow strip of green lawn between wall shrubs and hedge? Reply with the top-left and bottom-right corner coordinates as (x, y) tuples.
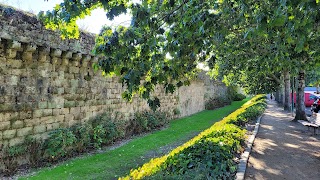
(20, 99), (248, 180)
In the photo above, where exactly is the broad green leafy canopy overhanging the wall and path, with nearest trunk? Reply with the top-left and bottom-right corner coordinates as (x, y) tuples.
(39, 0), (320, 119)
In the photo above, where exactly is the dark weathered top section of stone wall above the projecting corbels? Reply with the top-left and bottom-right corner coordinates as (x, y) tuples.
(0, 4), (95, 55)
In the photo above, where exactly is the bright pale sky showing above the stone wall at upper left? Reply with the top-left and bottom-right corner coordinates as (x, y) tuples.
(0, 0), (131, 33)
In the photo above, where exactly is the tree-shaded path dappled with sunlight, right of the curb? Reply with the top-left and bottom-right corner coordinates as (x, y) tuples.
(245, 101), (320, 180)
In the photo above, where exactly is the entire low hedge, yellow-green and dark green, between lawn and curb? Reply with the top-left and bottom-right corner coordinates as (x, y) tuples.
(119, 95), (266, 179)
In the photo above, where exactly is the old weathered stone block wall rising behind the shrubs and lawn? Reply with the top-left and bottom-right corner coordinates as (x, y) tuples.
(0, 6), (225, 147)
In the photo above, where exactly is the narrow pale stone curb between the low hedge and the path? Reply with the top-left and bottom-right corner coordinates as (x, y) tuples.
(236, 115), (262, 180)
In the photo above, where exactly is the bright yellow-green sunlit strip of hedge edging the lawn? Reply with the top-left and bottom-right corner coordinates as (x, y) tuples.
(119, 94), (266, 180)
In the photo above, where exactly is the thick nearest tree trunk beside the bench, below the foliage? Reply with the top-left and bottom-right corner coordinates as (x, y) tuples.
(294, 70), (307, 121)
